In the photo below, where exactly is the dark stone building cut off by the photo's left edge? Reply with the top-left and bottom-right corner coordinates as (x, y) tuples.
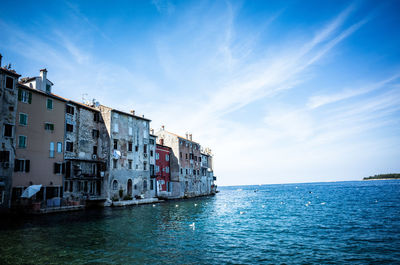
(0, 54), (20, 211)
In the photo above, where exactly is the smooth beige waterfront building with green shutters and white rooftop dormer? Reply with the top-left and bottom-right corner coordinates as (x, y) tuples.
(12, 69), (66, 203)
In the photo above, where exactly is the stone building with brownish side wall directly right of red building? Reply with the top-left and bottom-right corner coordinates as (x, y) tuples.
(156, 127), (205, 198)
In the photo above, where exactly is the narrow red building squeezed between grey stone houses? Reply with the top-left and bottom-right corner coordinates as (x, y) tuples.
(154, 141), (171, 197)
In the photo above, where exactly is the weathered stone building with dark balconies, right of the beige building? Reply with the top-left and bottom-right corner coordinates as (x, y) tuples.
(64, 100), (110, 202)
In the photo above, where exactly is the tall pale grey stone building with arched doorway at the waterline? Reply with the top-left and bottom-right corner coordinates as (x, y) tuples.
(98, 105), (154, 200)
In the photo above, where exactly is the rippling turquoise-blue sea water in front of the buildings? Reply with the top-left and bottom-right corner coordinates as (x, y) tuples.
(0, 180), (400, 264)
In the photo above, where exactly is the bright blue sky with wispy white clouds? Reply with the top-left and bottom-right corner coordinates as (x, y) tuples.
(0, 0), (400, 186)
